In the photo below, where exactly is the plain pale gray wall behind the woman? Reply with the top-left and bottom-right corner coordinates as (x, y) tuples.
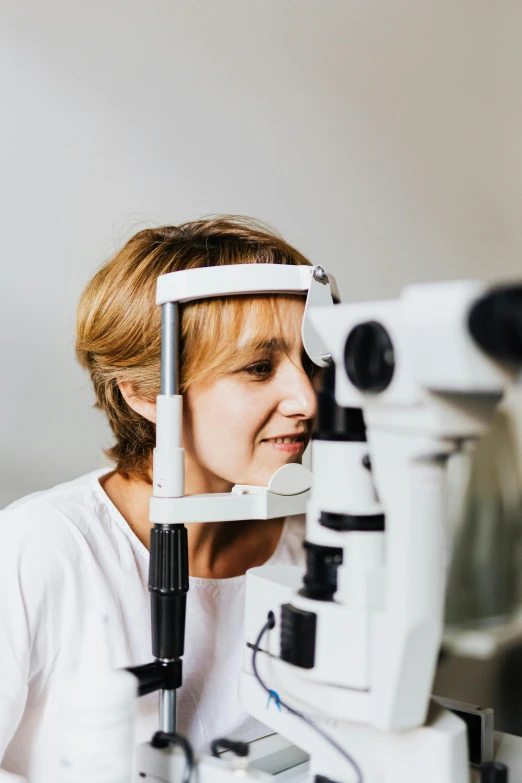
(0, 0), (522, 505)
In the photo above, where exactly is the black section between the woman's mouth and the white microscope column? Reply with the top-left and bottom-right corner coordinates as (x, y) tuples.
(312, 364), (366, 443)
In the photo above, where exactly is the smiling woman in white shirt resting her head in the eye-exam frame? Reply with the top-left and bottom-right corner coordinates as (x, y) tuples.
(0, 217), (316, 783)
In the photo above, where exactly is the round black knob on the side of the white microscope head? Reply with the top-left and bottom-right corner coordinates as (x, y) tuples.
(344, 321), (395, 393)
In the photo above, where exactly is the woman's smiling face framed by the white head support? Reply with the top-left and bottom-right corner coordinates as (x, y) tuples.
(183, 298), (316, 494)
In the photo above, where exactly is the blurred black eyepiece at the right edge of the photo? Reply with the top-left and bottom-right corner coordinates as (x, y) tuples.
(468, 284), (522, 364)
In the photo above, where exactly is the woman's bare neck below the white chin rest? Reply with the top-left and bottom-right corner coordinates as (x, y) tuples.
(100, 472), (283, 579)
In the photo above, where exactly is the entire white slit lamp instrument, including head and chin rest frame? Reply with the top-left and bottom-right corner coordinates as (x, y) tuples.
(77, 264), (522, 783)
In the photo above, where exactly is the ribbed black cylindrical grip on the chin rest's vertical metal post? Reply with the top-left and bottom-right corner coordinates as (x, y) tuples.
(149, 525), (189, 660)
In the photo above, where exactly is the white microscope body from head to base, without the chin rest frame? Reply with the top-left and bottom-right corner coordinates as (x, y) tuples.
(240, 281), (513, 783)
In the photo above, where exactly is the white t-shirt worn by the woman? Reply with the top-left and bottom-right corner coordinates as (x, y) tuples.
(0, 470), (304, 783)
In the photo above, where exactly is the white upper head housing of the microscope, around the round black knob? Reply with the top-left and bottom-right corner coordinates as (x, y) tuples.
(310, 280), (512, 428)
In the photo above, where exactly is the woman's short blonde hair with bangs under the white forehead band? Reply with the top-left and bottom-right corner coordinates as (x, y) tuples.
(76, 215), (310, 482)
